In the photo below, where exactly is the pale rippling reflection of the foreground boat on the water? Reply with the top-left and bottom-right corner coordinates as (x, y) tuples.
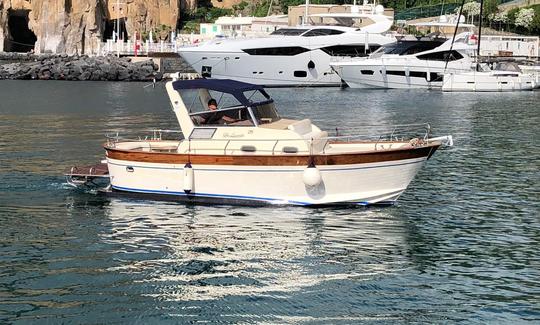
(100, 199), (408, 301)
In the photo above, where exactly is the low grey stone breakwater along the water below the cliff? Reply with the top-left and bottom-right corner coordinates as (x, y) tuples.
(0, 53), (163, 81)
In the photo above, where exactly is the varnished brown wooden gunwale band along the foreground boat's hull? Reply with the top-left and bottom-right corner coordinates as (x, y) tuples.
(104, 143), (440, 166)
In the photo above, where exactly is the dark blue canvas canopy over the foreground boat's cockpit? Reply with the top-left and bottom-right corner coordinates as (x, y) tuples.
(173, 79), (272, 106)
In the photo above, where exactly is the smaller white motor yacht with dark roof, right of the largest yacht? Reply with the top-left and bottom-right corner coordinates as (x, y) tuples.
(330, 32), (474, 89)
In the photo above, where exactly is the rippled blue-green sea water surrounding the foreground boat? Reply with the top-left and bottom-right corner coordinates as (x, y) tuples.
(0, 81), (540, 324)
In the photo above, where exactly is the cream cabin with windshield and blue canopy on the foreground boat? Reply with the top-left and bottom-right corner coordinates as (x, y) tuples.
(166, 79), (328, 155)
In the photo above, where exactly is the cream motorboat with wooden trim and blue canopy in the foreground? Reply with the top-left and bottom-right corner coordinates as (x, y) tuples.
(67, 79), (452, 206)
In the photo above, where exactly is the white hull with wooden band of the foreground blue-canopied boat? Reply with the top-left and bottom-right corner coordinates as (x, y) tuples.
(103, 145), (438, 205)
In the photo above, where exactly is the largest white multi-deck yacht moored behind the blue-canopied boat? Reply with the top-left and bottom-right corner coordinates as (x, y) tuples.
(179, 5), (395, 87)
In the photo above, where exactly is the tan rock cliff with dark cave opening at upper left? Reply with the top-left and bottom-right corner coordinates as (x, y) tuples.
(0, 0), (185, 54)
